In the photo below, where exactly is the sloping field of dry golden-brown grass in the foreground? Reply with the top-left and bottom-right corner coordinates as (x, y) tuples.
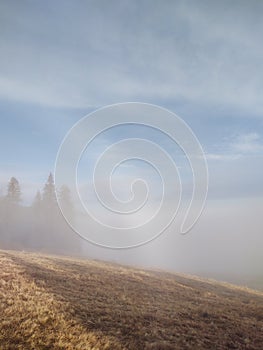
(0, 251), (263, 350)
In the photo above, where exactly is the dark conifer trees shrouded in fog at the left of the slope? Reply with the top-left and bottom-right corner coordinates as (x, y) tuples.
(0, 173), (81, 255)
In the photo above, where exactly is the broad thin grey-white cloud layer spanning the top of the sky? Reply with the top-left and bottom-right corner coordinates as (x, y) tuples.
(0, 1), (263, 116)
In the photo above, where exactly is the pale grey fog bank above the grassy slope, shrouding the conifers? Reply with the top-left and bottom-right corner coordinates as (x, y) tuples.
(0, 175), (263, 289)
